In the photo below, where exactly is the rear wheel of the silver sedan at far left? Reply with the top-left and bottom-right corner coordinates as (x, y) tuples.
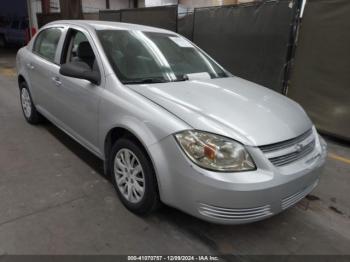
(20, 82), (42, 125)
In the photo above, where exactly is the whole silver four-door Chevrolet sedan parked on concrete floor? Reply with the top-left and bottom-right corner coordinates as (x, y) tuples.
(17, 21), (326, 224)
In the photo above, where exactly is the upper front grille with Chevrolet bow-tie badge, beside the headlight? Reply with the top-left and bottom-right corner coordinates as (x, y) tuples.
(259, 129), (315, 167)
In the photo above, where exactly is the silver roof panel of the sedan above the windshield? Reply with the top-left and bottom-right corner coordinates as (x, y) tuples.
(47, 20), (175, 34)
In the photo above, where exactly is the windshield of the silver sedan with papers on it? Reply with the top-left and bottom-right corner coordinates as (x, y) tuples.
(97, 30), (227, 84)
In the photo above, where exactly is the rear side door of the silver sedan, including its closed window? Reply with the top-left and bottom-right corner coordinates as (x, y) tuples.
(25, 27), (64, 118)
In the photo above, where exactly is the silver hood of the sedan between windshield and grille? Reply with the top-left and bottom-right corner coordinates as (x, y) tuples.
(128, 77), (312, 146)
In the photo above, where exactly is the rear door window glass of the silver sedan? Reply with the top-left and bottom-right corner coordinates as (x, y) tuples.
(33, 28), (62, 62)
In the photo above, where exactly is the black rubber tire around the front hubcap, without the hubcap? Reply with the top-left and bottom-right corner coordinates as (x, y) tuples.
(109, 137), (160, 215)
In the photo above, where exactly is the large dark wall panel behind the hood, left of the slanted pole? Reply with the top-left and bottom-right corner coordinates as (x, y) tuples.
(193, 0), (297, 92)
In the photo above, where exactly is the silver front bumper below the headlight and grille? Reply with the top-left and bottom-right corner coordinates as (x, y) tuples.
(149, 136), (327, 224)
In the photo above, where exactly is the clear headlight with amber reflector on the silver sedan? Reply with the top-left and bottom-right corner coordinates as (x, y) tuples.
(175, 130), (256, 172)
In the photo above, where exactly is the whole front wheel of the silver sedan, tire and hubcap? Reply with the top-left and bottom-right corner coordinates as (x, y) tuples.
(110, 138), (160, 215)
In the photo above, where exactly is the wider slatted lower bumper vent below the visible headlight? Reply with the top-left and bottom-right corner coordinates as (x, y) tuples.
(198, 203), (272, 220)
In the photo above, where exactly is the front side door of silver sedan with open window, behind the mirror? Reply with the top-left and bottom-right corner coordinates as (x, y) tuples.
(55, 27), (104, 152)
